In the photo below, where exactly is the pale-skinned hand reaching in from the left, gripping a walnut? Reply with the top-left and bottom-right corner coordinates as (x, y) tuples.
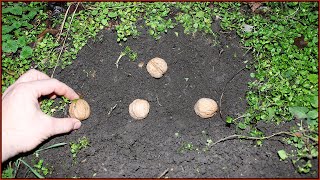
(2, 69), (81, 162)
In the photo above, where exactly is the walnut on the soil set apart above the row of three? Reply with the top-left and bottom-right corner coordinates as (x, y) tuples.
(147, 57), (168, 78)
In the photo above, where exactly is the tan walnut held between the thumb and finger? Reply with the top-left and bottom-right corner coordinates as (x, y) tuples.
(69, 99), (90, 121)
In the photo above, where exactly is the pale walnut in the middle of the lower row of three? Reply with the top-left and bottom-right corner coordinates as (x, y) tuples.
(129, 99), (150, 119)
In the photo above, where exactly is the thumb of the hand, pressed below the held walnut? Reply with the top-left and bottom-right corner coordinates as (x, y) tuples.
(51, 117), (81, 135)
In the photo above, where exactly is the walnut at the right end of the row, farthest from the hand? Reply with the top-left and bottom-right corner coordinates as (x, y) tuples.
(194, 98), (218, 118)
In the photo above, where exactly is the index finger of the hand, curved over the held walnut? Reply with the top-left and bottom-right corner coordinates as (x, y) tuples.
(28, 79), (79, 100)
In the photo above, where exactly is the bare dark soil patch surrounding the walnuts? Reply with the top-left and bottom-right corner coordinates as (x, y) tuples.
(18, 20), (317, 178)
